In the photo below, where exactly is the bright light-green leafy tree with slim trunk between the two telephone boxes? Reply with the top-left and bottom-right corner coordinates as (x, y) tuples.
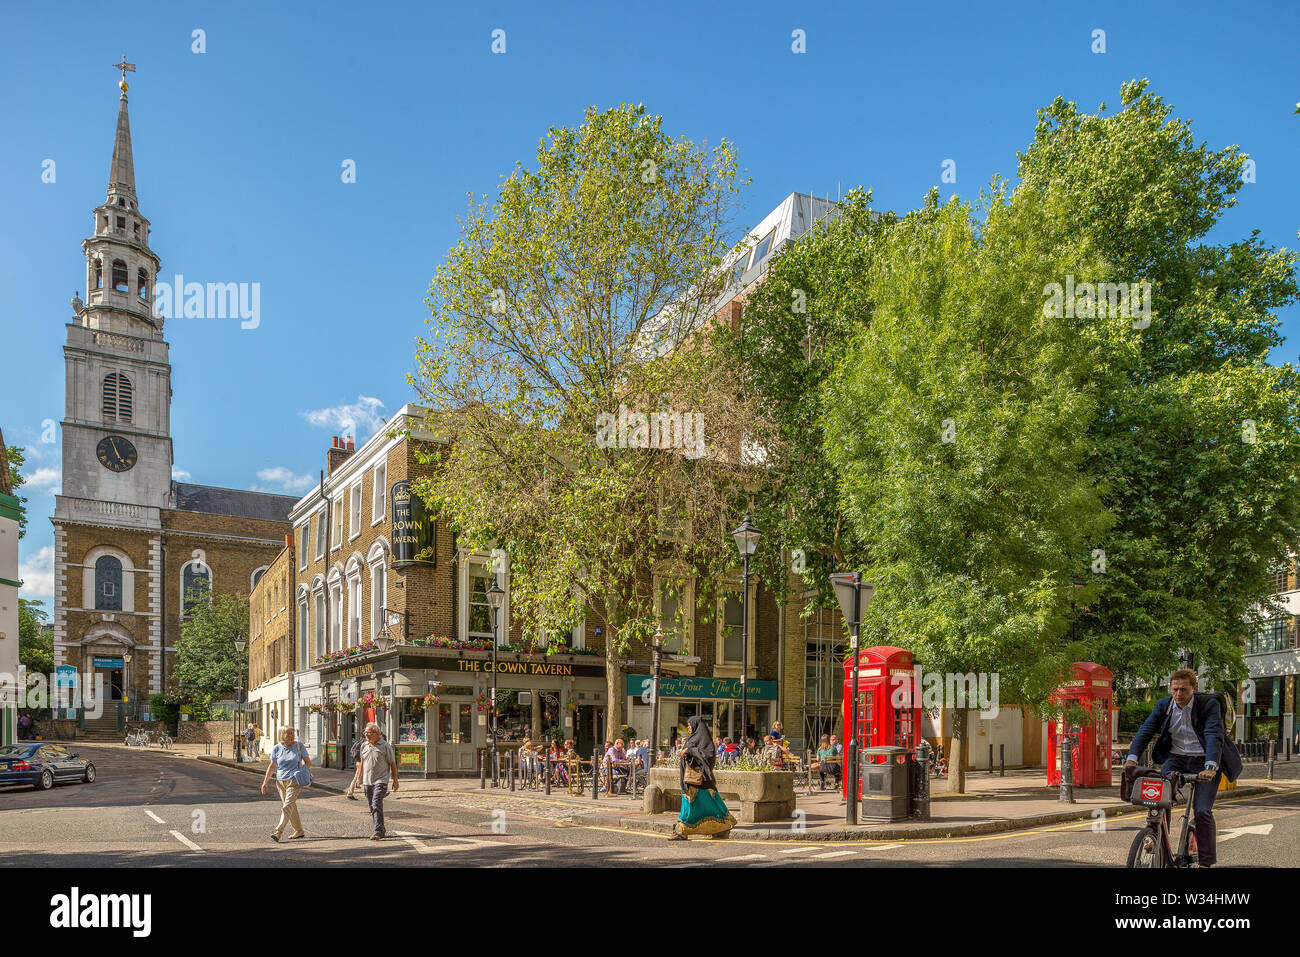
(826, 185), (1122, 791)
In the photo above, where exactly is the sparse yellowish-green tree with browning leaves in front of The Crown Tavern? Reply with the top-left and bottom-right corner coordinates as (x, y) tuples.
(415, 105), (762, 732)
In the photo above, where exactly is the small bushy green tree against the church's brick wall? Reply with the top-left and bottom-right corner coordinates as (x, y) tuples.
(174, 581), (248, 700)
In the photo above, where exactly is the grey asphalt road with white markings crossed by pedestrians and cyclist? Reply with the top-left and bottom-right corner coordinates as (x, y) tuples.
(0, 746), (1300, 869)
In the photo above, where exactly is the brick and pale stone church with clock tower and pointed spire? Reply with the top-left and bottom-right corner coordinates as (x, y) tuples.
(52, 70), (296, 736)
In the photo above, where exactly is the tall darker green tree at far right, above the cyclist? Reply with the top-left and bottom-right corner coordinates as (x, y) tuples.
(1019, 81), (1300, 683)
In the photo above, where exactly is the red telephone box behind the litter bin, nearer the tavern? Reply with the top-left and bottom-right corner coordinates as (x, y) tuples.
(840, 645), (920, 798)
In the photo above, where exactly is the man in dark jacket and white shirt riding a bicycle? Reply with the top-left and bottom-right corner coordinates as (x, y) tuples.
(1125, 668), (1242, 867)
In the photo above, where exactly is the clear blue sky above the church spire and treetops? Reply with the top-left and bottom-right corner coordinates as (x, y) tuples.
(0, 0), (1300, 602)
